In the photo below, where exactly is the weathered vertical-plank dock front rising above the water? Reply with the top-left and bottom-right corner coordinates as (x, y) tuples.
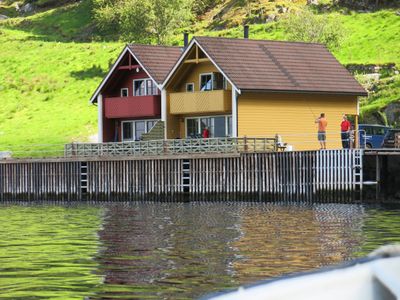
(0, 150), (362, 201)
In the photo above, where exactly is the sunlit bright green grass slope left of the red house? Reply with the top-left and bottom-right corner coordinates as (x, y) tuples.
(0, 22), (122, 156)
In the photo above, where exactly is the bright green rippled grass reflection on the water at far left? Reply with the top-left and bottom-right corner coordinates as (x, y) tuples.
(0, 205), (101, 299)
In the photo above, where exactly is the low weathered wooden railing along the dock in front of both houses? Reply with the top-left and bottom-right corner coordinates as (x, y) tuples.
(65, 137), (278, 157)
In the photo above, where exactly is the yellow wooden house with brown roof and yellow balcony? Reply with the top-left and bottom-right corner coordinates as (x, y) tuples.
(162, 37), (367, 150)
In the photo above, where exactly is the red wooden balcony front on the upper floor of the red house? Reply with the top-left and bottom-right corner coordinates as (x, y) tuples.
(104, 95), (161, 119)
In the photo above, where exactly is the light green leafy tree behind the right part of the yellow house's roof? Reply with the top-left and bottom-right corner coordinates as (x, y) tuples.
(283, 10), (344, 50)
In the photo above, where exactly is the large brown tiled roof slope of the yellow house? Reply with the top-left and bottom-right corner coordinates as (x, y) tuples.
(195, 37), (367, 95)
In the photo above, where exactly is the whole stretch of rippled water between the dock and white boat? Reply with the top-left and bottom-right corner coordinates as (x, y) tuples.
(0, 203), (400, 299)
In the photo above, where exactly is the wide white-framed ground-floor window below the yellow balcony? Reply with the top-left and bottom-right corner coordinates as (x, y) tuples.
(186, 116), (232, 138)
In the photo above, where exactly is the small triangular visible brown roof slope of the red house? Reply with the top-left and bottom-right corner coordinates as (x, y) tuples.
(128, 44), (182, 84)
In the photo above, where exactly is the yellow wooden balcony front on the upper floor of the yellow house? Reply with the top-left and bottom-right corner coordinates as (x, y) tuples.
(170, 90), (232, 115)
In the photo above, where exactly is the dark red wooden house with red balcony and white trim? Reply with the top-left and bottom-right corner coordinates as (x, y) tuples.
(90, 44), (182, 143)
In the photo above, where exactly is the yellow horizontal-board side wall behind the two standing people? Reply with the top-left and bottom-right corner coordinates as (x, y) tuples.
(238, 93), (357, 150)
